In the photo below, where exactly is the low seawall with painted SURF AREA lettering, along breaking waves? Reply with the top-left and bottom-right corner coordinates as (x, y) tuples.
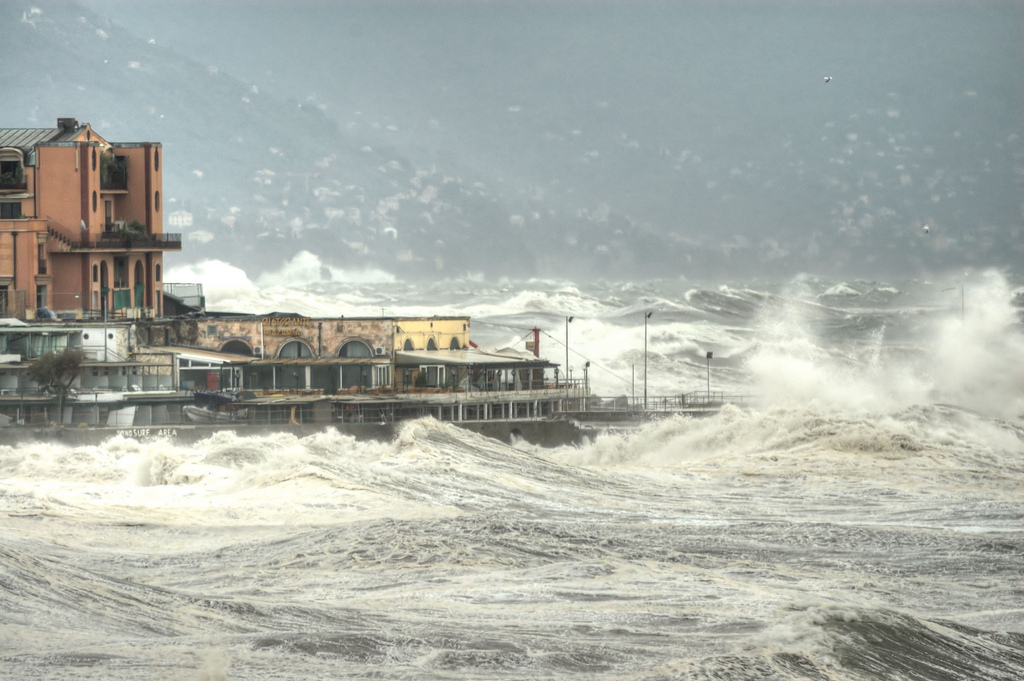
(0, 421), (596, 446)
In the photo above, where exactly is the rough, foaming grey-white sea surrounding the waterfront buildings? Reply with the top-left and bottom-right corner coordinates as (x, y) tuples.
(0, 270), (1024, 681)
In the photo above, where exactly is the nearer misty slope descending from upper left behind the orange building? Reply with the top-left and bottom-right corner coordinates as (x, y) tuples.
(2, 3), (552, 273)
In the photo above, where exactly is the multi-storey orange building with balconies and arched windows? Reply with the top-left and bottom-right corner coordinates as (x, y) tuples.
(0, 118), (181, 318)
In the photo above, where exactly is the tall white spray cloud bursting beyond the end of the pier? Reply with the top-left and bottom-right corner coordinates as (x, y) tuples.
(748, 271), (1024, 417)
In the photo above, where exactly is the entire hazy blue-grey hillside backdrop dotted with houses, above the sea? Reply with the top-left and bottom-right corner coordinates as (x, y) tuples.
(0, 0), (1024, 278)
